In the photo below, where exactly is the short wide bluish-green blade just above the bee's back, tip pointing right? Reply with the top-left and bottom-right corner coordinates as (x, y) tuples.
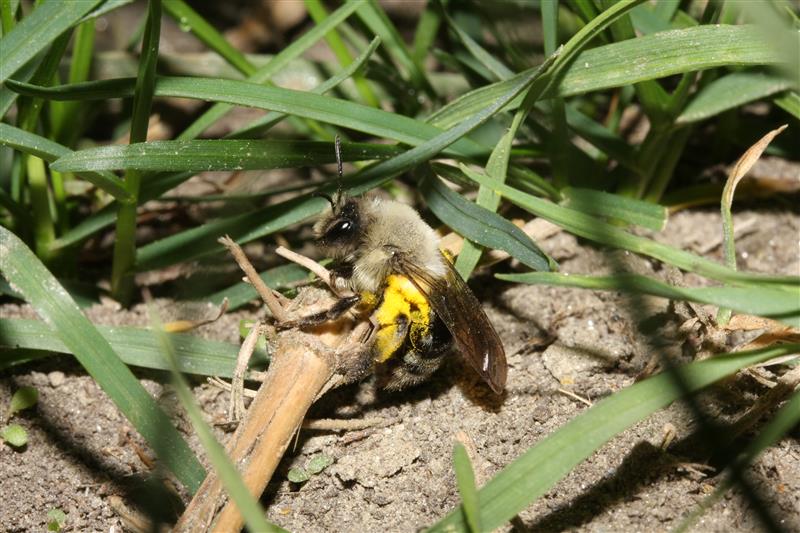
(420, 174), (556, 271)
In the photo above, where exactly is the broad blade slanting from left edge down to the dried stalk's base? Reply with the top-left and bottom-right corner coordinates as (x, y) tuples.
(0, 227), (205, 492)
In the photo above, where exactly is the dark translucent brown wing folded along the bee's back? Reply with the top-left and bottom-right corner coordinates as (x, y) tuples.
(396, 251), (507, 394)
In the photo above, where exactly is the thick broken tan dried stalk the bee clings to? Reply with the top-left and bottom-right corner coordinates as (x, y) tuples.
(174, 239), (370, 532)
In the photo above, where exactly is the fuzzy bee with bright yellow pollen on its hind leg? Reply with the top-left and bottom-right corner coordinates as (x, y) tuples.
(301, 189), (507, 394)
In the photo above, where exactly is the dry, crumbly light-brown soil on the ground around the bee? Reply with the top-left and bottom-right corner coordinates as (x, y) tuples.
(0, 205), (800, 532)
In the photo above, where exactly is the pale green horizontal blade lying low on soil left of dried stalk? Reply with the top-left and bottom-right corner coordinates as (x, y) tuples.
(0, 319), (266, 378)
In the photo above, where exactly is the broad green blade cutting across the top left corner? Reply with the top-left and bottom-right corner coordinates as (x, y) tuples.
(0, 0), (102, 84)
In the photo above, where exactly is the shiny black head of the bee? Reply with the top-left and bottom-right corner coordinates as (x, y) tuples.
(314, 193), (367, 257)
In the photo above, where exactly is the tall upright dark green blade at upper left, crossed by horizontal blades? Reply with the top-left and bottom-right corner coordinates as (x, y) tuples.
(111, 0), (161, 304)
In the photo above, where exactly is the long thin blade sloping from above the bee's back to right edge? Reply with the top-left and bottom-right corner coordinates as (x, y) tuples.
(454, 165), (800, 286)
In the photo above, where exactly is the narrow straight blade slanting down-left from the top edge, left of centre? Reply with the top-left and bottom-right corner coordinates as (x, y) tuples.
(178, 0), (358, 140)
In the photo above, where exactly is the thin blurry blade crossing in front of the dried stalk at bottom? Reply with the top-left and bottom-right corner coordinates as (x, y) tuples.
(147, 304), (283, 531)
